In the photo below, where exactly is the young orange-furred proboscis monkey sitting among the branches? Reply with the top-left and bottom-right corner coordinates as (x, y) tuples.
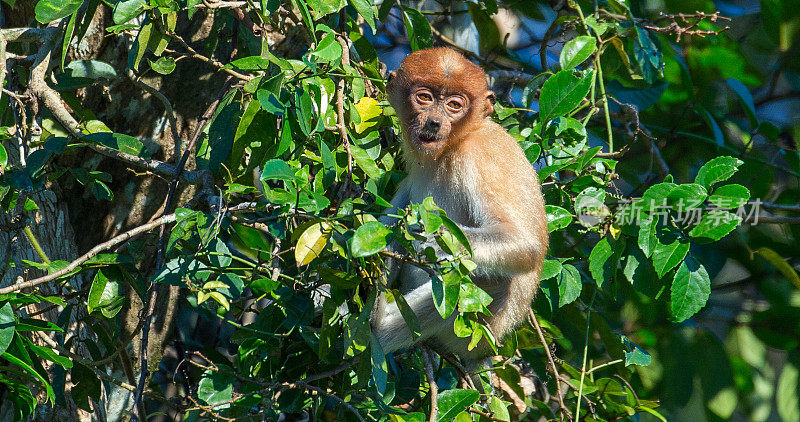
(372, 48), (548, 364)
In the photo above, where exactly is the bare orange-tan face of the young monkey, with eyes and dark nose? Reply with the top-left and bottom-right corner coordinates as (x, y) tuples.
(405, 86), (470, 152)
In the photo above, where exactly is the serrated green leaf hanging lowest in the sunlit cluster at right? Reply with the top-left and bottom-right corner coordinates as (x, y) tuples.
(670, 257), (711, 322)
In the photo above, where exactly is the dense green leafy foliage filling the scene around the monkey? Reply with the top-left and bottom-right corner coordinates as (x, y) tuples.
(0, 0), (800, 421)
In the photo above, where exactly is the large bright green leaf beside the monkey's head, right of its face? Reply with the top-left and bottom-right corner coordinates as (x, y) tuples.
(539, 70), (592, 123)
